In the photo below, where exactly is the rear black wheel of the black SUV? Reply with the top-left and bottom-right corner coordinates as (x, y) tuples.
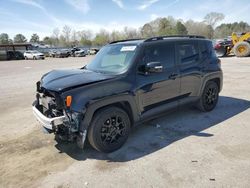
(197, 81), (219, 112)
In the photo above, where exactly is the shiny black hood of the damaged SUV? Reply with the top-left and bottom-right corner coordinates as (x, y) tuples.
(41, 69), (114, 92)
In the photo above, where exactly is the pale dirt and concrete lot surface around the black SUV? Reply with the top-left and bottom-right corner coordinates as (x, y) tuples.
(0, 57), (250, 188)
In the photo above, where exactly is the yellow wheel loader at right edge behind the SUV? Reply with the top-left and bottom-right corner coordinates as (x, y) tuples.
(215, 32), (250, 57)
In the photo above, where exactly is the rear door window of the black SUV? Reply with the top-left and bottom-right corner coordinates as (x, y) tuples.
(177, 43), (199, 63)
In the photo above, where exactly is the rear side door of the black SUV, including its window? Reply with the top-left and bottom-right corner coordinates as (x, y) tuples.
(176, 41), (203, 97)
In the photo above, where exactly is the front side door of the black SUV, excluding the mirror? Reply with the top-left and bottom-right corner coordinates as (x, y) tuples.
(136, 41), (180, 112)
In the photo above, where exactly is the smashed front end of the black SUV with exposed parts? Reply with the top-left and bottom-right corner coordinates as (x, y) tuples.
(32, 82), (86, 148)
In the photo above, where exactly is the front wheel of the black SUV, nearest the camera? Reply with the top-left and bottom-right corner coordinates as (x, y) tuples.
(88, 107), (131, 153)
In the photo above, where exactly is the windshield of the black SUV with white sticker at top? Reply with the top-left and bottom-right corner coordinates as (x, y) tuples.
(86, 44), (136, 74)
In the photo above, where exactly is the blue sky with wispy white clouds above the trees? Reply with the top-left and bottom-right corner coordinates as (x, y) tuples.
(0, 0), (250, 38)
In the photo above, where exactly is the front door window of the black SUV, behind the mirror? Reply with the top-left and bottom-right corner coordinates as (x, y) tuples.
(142, 43), (175, 69)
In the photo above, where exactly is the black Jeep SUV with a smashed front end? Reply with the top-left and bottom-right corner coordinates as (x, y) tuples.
(33, 35), (223, 152)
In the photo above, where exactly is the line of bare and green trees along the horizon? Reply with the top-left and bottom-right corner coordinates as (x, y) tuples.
(0, 12), (250, 47)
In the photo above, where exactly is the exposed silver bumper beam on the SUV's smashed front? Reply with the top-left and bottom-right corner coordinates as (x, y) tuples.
(32, 105), (65, 131)
